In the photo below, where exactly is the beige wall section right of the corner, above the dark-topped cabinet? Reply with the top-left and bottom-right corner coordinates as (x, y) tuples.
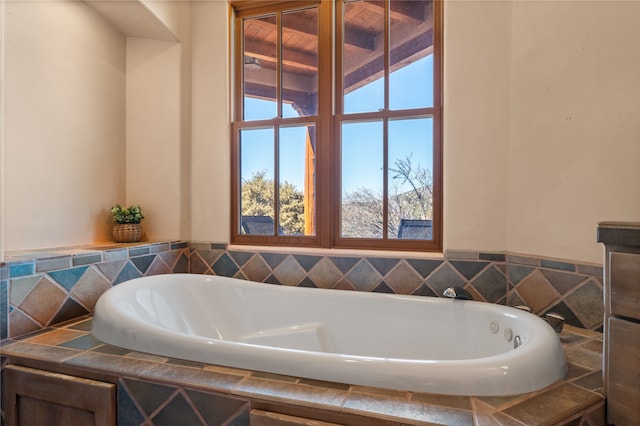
(507, 1), (640, 261)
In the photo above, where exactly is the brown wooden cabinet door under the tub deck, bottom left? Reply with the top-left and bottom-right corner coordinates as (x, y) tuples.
(2, 365), (116, 426)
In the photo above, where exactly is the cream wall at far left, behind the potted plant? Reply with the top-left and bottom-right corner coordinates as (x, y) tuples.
(2, 1), (125, 250)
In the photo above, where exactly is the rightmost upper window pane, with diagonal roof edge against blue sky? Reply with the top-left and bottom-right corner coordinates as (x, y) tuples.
(389, 0), (433, 110)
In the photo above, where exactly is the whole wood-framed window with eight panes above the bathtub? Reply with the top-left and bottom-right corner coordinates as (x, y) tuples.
(231, 0), (442, 251)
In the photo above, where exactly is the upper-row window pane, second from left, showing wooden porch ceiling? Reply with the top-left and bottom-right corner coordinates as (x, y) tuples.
(281, 8), (318, 118)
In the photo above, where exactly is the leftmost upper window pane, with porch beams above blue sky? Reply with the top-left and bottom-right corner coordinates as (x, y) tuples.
(242, 15), (278, 120)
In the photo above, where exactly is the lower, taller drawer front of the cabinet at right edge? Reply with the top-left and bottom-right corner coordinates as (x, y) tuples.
(607, 318), (640, 425)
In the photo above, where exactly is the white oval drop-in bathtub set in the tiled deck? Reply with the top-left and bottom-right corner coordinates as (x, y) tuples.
(93, 274), (567, 396)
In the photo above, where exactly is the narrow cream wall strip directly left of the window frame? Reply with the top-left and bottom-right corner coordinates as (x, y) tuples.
(191, 2), (231, 242)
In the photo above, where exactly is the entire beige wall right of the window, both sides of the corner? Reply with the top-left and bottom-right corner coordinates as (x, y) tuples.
(444, 1), (640, 262)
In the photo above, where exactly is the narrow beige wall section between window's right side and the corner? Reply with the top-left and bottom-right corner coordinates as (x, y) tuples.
(443, 1), (511, 255)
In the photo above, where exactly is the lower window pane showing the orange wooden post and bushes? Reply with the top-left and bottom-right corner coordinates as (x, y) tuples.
(278, 126), (315, 235)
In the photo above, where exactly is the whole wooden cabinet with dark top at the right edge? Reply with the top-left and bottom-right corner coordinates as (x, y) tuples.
(598, 223), (640, 426)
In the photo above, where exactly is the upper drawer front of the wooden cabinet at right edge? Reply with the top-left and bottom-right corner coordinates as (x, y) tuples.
(610, 253), (640, 320)
